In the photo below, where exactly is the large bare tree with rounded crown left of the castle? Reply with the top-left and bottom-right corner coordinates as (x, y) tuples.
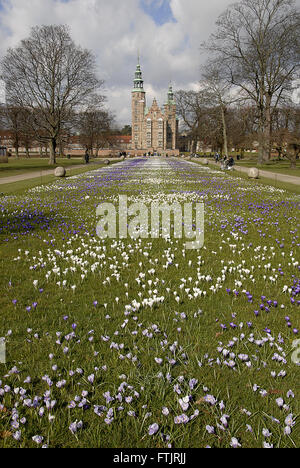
(1, 25), (103, 164)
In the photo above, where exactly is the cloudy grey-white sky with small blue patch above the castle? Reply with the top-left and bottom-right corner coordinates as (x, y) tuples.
(0, 0), (300, 125)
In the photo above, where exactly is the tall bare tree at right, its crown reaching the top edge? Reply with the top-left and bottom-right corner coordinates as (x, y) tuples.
(202, 0), (300, 163)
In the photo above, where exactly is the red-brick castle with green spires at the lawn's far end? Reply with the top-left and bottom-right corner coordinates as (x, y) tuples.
(131, 59), (179, 156)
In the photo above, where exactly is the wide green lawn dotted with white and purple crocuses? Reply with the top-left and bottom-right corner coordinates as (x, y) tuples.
(0, 159), (300, 449)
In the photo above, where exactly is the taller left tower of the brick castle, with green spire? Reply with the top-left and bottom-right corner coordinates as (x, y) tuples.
(131, 60), (146, 149)
